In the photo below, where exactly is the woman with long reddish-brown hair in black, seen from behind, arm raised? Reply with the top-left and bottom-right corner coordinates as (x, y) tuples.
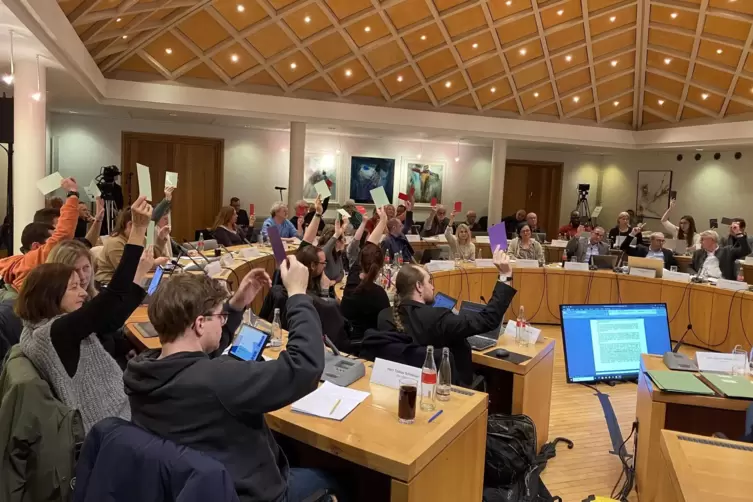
(340, 208), (390, 340)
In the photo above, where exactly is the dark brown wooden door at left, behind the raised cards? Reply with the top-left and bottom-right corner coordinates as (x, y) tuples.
(122, 132), (224, 242)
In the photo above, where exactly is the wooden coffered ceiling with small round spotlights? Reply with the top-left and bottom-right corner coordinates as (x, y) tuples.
(59, 0), (753, 129)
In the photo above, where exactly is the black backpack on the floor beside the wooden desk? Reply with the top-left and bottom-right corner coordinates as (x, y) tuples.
(484, 414), (573, 502)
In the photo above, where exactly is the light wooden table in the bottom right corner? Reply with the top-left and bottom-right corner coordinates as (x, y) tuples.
(652, 430), (753, 502)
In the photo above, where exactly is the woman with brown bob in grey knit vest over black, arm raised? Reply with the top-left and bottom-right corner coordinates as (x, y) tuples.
(16, 197), (154, 432)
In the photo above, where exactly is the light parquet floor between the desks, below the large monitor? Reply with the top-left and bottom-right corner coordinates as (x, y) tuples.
(538, 326), (638, 502)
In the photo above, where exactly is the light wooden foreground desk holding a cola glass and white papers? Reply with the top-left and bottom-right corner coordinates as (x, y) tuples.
(126, 307), (488, 502)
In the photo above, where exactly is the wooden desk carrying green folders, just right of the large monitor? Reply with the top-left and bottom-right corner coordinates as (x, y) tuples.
(635, 354), (753, 502)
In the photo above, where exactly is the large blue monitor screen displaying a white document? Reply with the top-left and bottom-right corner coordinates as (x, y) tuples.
(560, 303), (671, 383)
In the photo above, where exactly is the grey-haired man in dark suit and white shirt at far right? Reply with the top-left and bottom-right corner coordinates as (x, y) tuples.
(690, 223), (750, 281)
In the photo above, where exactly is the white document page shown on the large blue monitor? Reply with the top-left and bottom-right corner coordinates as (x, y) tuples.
(591, 319), (647, 373)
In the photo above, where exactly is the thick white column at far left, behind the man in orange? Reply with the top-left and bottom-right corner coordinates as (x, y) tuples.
(13, 59), (47, 253)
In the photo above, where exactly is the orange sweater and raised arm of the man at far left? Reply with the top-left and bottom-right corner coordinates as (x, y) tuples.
(0, 178), (78, 291)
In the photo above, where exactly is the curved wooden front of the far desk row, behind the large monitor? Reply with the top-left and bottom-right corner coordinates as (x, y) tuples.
(432, 264), (753, 352)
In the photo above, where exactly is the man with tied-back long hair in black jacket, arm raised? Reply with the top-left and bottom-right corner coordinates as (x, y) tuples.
(378, 250), (515, 385)
